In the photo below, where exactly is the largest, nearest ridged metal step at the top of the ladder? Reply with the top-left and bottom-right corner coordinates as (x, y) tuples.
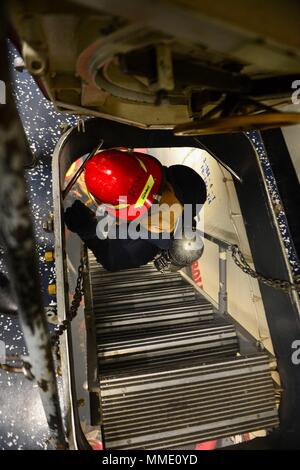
(101, 355), (278, 449)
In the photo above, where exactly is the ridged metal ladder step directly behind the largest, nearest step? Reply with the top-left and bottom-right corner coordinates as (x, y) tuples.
(97, 324), (238, 375)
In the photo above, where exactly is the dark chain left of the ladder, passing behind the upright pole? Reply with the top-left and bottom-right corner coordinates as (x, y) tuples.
(0, 258), (84, 380)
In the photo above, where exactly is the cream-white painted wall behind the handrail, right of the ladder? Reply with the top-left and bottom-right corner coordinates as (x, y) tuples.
(148, 148), (273, 353)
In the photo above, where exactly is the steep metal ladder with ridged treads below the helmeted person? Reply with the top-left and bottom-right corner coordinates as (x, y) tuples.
(88, 252), (278, 449)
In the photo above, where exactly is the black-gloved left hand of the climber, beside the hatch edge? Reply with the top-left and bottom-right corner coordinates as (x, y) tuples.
(65, 199), (97, 240)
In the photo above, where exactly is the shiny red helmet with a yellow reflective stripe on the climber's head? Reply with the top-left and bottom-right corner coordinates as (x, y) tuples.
(85, 149), (163, 220)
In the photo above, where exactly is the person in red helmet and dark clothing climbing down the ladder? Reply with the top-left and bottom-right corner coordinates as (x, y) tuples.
(65, 149), (206, 271)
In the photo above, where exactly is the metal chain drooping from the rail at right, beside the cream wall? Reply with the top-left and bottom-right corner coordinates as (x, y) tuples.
(230, 245), (300, 292)
